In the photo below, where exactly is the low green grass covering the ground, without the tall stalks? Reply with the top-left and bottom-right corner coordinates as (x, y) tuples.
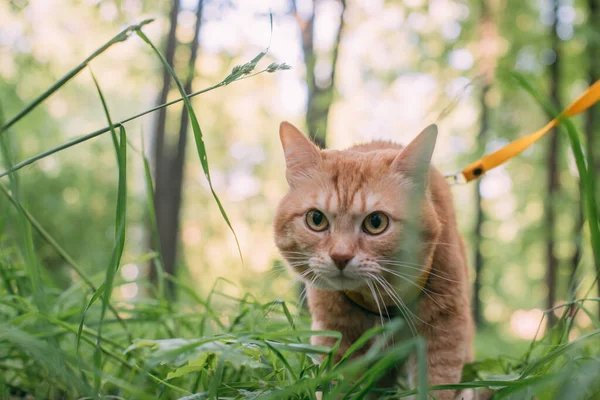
(0, 254), (600, 399)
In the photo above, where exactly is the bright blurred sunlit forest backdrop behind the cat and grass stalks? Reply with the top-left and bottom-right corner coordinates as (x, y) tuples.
(0, 0), (600, 353)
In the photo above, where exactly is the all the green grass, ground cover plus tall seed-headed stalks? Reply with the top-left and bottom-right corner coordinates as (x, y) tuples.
(0, 24), (600, 399)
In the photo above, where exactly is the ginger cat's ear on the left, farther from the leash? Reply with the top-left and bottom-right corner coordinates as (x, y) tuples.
(279, 121), (321, 186)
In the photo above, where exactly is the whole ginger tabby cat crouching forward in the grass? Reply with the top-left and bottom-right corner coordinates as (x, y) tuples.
(274, 122), (473, 400)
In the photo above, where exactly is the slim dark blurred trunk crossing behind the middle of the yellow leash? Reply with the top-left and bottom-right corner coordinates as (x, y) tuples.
(544, 0), (561, 325)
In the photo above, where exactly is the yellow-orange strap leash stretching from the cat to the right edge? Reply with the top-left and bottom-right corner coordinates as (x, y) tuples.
(446, 80), (600, 183)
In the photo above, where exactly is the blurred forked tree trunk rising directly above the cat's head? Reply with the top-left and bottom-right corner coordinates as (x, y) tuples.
(292, 0), (346, 148)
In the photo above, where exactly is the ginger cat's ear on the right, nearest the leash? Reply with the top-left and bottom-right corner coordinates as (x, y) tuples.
(392, 125), (437, 182)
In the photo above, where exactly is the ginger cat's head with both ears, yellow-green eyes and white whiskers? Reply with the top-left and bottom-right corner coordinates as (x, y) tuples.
(275, 123), (440, 296)
